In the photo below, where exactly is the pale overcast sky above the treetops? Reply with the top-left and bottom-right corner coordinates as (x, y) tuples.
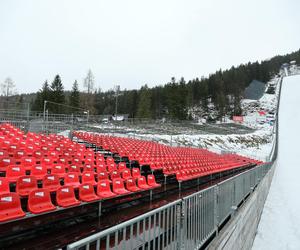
(0, 0), (300, 93)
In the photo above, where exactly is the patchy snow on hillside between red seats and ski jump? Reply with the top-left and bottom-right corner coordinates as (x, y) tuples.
(89, 77), (280, 161)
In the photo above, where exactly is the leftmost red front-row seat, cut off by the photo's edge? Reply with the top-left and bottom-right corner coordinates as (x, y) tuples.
(0, 193), (25, 222)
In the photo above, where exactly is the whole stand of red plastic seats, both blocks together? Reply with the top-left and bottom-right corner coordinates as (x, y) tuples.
(0, 123), (262, 247)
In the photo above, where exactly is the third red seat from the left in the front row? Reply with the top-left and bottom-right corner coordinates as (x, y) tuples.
(56, 186), (80, 207)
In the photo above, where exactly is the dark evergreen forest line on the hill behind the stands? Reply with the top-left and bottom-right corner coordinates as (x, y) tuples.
(32, 50), (300, 120)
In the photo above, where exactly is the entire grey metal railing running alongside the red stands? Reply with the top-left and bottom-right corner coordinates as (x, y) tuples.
(67, 163), (272, 250)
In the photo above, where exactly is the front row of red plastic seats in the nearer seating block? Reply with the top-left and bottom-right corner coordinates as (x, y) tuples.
(0, 176), (160, 222)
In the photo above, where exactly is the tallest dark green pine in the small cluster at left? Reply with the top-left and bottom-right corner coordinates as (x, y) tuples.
(48, 75), (65, 114)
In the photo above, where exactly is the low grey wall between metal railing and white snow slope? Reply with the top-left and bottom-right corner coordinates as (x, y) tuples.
(208, 162), (276, 250)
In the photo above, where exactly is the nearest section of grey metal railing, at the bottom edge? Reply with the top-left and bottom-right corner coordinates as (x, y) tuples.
(67, 200), (181, 250)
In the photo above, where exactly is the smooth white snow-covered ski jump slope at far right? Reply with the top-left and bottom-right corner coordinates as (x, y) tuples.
(252, 75), (300, 250)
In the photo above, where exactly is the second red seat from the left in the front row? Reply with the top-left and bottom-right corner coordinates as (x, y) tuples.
(27, 188), (56, 214)
